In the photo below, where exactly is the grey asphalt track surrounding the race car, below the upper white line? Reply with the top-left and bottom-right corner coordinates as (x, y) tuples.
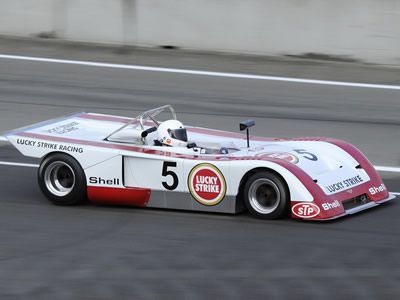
(0, 40), (400, 299)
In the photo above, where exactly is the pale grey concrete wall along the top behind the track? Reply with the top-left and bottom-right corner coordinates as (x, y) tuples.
(0, 0), (400, 64)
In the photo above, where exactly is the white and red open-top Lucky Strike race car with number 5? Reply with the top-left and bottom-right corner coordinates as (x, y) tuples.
(0, 105), (395, 220)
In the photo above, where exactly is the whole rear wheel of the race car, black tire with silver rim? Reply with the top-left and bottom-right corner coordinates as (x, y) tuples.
(38, 153), (87, 205)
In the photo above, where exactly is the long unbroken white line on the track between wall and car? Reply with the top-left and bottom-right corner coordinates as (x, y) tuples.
(0, 54), (400, 90)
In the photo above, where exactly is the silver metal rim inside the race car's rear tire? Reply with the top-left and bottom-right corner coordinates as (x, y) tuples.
(44, 161), (75, 197)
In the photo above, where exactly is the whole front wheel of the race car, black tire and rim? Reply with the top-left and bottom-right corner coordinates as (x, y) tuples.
(243, 171), (290, 220)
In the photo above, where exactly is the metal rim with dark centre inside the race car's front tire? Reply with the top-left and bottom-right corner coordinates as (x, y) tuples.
(248, 178), (281, 214)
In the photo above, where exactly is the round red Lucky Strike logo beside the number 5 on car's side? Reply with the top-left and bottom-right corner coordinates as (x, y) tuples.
(188, 164), (226, 205)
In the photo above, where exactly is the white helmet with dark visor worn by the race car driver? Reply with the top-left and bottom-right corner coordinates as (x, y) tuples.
(157, 120), (187, 147)
